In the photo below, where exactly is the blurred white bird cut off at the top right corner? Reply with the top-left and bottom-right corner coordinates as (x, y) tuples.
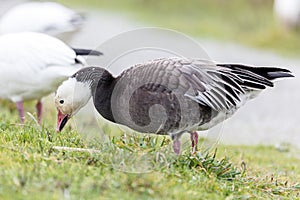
(274, 0), (300, 28)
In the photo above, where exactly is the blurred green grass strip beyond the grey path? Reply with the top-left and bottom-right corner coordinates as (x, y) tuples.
(58, 0), (300, 56)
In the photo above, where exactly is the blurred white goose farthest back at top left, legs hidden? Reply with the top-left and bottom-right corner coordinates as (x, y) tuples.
(0, 2), (83, 36)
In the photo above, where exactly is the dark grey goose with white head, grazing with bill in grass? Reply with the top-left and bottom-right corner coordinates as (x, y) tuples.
(55, 58), (293, 154)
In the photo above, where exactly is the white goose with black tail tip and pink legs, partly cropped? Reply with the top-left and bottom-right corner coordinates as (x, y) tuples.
(0, 32), (101, 123)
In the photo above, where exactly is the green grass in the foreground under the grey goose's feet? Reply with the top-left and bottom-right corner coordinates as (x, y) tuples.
(0, 102), (300, 199)
